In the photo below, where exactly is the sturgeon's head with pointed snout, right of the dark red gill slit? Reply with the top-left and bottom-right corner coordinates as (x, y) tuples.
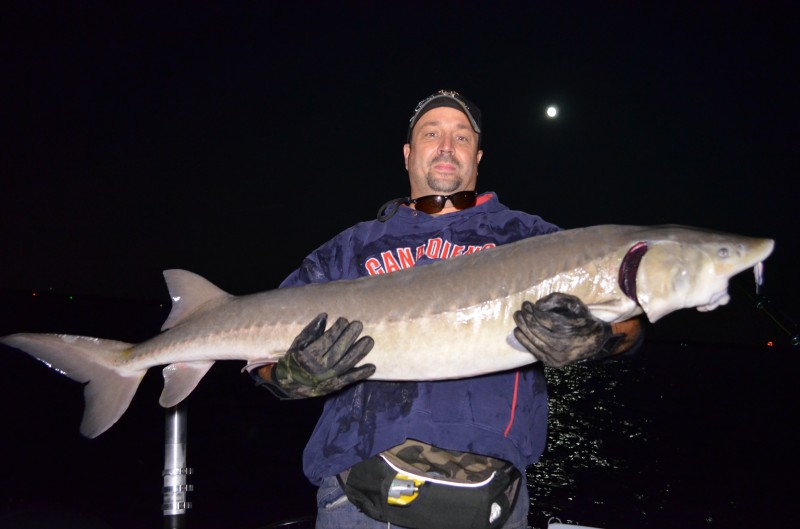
(632, 226), (775, 322)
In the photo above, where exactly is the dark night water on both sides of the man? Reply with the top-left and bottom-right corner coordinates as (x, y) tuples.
(0, 293), (800, 529)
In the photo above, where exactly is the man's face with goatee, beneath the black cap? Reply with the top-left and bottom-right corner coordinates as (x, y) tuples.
(403, 107), (483, 198)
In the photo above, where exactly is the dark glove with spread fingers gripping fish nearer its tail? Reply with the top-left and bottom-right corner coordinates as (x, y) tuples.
(256, 312), (375, 399)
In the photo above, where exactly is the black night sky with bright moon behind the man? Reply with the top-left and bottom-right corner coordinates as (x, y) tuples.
(0, 1), (800, 524)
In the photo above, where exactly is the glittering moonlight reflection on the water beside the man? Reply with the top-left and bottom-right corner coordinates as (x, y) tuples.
(528, 360), (648, 527)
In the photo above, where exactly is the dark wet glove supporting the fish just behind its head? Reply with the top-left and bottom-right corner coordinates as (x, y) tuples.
(514, 292), (625, 367)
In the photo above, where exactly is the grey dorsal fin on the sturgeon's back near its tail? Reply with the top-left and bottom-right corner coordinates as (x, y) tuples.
(161, 270), (233, 331)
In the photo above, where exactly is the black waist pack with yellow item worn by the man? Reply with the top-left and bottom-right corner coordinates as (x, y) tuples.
(339, 440), (522, 529)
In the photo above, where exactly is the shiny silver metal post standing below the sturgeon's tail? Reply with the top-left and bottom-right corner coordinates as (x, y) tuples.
(161, 403), (193, 529)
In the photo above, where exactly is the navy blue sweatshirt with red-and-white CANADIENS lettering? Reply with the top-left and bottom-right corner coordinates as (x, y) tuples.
(281, 193), (558, 484)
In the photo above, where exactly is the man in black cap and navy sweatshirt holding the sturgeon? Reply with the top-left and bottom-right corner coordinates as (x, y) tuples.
(257, 90), (640, 529)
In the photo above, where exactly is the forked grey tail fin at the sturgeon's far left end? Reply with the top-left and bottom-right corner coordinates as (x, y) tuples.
(0, 334), (145, 437)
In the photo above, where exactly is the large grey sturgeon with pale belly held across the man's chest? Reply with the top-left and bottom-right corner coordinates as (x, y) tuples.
(0, 225), (774, 437)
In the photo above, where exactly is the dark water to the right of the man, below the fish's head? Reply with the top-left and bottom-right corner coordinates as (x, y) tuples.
(529, 343), (800, 528)
